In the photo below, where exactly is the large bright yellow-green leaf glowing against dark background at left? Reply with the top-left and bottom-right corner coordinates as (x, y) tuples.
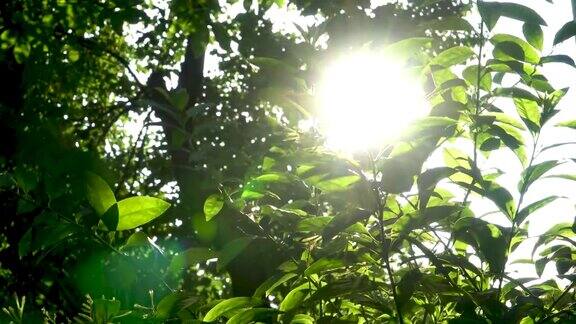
(116, 196), (170, 231)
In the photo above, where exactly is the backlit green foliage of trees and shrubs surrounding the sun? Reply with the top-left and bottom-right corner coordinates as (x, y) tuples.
(0, 0), (576, 324)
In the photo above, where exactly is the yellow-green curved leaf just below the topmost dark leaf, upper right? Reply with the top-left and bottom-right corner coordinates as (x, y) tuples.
(490, 34), (540, 64)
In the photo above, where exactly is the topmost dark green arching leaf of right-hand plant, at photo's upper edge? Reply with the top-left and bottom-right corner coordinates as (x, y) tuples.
(478, 1), (546, 30)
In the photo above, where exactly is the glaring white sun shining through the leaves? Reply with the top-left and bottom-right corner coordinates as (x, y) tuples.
(318, 52), (428, 153)
